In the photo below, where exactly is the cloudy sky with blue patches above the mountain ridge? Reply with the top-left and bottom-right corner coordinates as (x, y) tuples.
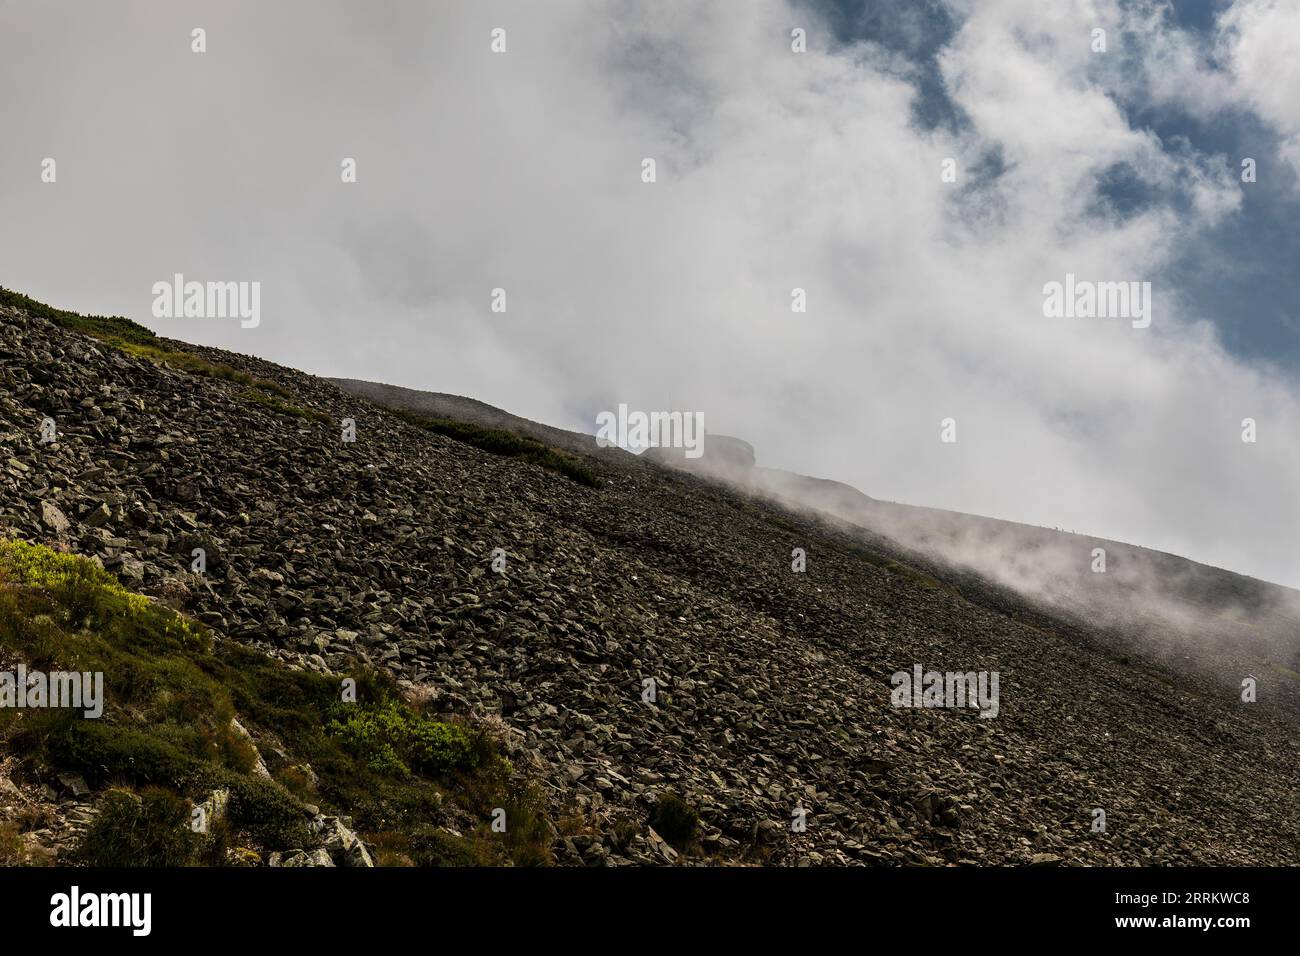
(0, 0), (1300, 587)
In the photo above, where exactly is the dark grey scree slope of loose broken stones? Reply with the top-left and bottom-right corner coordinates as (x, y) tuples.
(0, 299), (1300, 865)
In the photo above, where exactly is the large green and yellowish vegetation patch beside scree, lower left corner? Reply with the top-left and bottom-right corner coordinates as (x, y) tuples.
(0, 540), (550, 865)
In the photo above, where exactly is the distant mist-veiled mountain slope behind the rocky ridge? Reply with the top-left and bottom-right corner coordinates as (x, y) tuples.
(332, 378), (1300, 697)
